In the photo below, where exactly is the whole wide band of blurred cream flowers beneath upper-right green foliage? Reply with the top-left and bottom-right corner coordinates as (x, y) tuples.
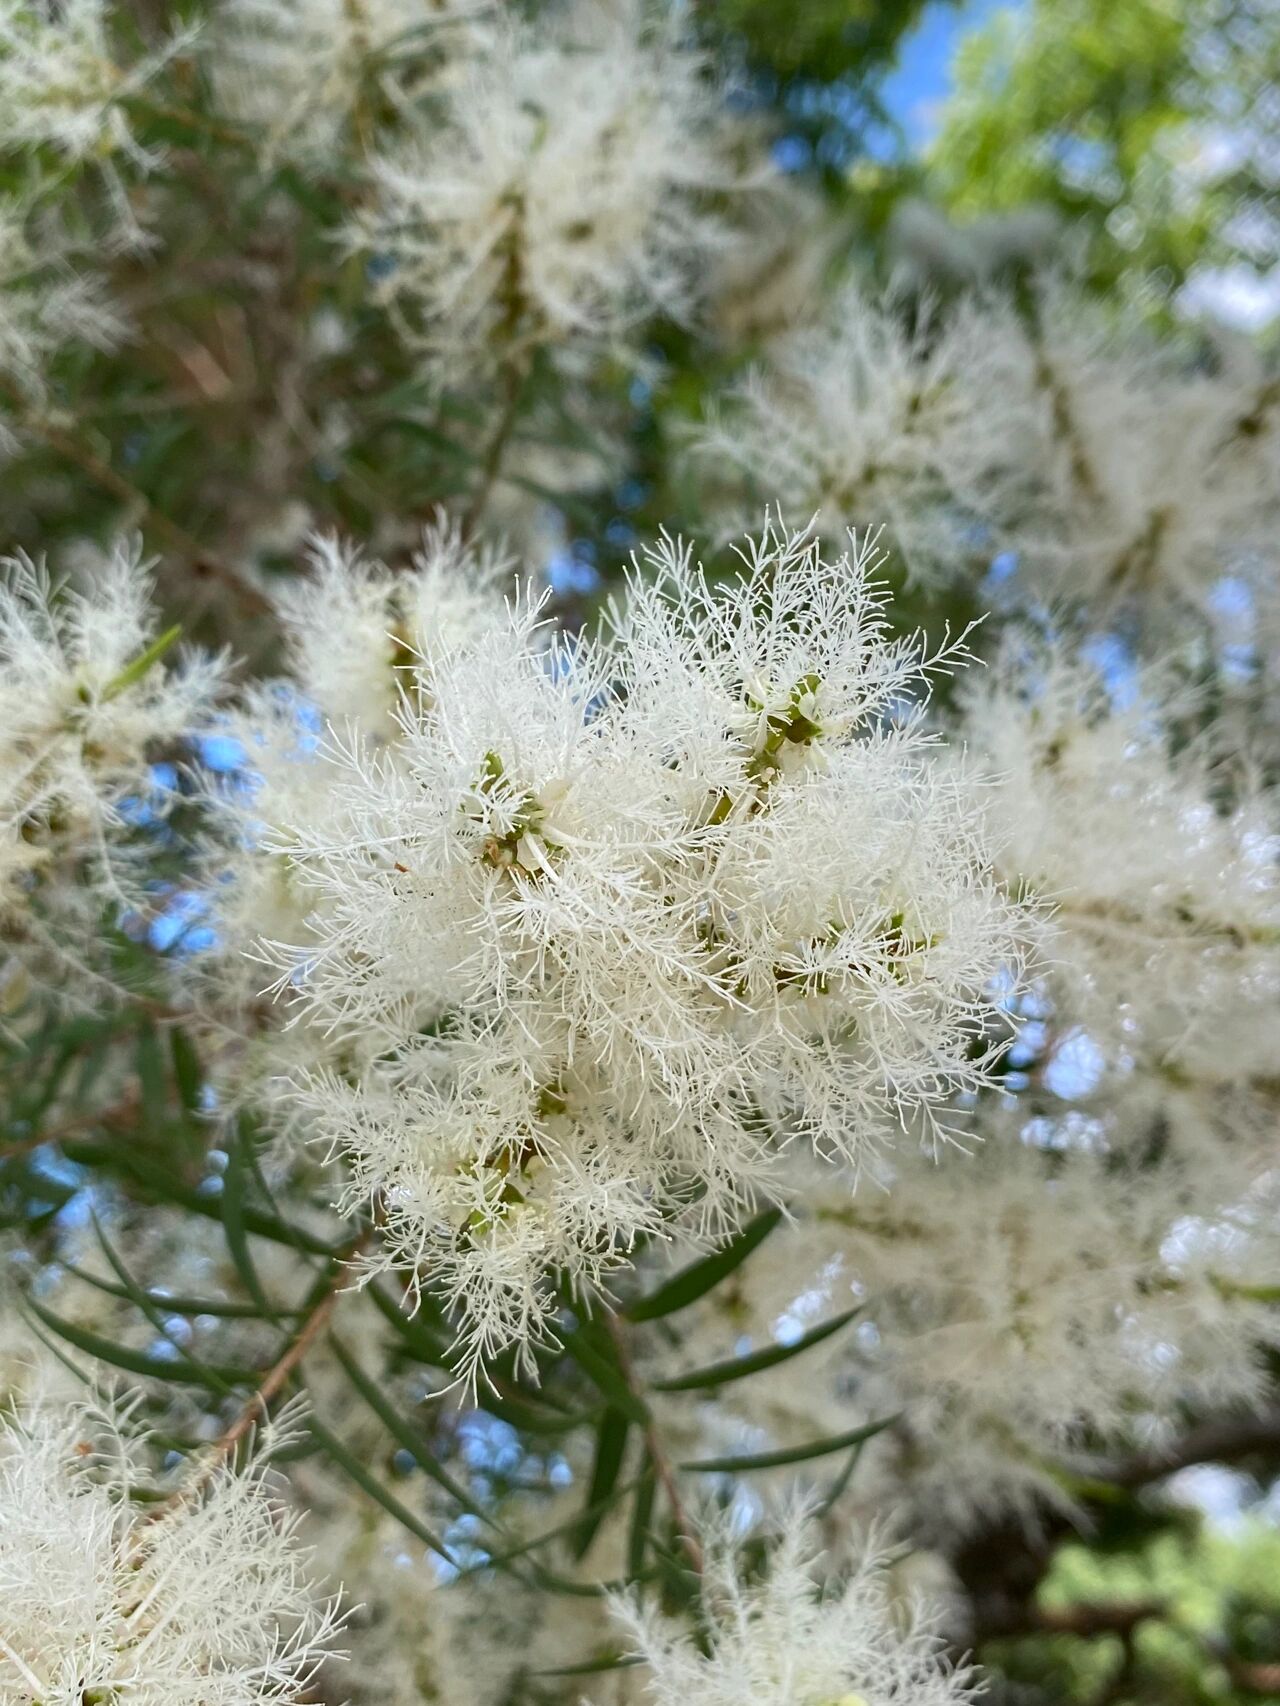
(713, 281), (1280, 619)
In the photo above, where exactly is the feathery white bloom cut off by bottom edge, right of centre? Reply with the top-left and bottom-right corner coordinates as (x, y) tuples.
(616, 1510), (975, 1706)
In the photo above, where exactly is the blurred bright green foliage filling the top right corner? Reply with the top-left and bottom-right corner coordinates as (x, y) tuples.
(928, 0), (1280, 303)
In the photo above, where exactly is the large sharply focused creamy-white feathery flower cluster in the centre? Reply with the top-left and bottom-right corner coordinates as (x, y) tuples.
(225, 525), (1019, 1353)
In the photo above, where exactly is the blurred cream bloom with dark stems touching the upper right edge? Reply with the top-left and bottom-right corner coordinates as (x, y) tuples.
(966, 285), (1280, 621)
